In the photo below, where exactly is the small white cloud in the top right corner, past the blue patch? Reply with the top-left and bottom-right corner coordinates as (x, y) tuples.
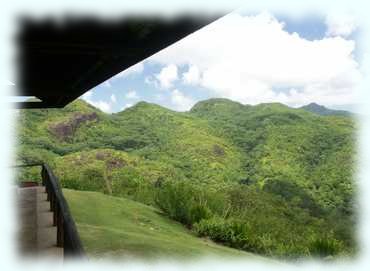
(325, 14), (357, 37)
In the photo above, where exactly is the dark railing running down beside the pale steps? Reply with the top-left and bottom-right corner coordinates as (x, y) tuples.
(15, 164), (85, 258)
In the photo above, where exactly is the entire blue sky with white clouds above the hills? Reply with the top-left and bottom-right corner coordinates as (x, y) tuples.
(82, 12), (361, 113)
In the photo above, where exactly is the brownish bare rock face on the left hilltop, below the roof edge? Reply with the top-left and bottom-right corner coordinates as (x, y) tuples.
(49, 112), (98, 141)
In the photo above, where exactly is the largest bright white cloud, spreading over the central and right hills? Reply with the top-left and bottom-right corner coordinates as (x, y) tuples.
(147, 13), (361, 105)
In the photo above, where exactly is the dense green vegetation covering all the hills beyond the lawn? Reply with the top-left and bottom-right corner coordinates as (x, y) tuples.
(18, 99), (356, 258)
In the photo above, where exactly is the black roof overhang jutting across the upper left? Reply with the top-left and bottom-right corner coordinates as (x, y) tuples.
(16, 15), (220, 108)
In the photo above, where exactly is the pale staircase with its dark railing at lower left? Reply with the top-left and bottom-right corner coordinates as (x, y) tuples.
(16, 164), (85, 260)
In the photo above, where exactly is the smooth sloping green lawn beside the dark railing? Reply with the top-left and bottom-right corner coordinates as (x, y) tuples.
(63, 189), (257, 259)
